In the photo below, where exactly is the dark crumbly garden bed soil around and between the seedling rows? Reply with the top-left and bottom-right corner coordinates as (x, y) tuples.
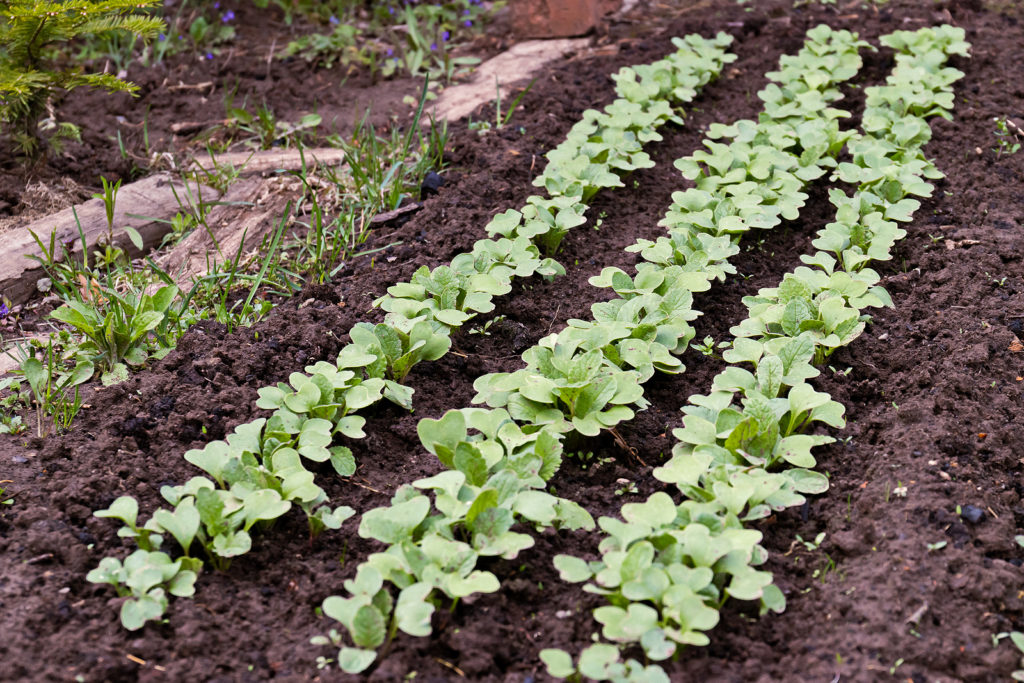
(0, 2), (1024, 682)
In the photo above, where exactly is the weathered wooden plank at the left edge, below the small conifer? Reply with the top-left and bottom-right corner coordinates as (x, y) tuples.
(0, 173), (220, 304)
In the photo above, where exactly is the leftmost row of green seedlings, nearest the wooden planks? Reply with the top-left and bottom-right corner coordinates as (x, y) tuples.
(89, 34), (735, 629)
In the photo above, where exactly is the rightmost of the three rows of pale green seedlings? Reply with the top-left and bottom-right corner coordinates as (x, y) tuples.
(542, 26), (969, 681)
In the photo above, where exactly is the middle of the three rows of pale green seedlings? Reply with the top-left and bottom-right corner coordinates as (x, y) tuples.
(316, 28), (876, 673)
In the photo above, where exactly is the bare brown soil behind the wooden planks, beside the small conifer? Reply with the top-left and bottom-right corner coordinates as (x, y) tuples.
(0, 0), (508, 216)
